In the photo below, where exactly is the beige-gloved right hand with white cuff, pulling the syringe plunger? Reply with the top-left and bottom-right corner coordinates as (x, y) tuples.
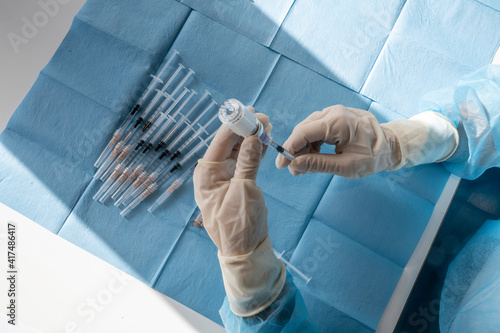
(276, 105), (458, 178)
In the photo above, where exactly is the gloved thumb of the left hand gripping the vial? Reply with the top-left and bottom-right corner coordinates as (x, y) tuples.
(234, 135), (262, 180)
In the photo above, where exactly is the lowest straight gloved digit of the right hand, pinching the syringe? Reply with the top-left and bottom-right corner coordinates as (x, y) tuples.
(290, 153), (363, 178)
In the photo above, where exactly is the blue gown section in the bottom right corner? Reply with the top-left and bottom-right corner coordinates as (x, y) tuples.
(439, 220), (500, 333)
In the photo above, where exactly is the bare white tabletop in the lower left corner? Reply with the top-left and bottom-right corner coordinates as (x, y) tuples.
(0, 204), (225, 333)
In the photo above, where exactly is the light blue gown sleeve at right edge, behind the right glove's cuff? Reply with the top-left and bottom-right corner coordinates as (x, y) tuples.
(419, 65), (500, 180)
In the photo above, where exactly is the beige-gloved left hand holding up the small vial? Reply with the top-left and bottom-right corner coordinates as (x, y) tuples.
(193, 114), (286, 317)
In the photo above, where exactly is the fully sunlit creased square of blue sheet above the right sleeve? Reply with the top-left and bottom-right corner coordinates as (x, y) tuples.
(361, 0), (500, 117)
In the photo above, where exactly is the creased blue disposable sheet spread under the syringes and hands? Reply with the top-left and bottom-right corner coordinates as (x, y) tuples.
(0, 0), (500, 332)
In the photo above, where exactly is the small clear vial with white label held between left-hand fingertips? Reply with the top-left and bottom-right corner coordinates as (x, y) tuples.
(219, 98), (262, 137)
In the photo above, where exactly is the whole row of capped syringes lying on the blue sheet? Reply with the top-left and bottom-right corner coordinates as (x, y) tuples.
(94, 50), (217, 216)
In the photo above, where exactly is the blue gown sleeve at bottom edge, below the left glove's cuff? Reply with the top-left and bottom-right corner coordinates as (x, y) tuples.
(219, 272), (319, 333)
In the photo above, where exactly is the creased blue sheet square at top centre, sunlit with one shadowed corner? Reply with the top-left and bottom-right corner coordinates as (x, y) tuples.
(271, 0), (405, 92)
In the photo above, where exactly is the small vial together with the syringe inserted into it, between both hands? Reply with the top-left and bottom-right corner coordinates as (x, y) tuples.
(219, 99), (295, 161)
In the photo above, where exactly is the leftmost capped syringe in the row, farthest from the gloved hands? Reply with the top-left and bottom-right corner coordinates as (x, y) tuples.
(94, 50), (179, 168)
